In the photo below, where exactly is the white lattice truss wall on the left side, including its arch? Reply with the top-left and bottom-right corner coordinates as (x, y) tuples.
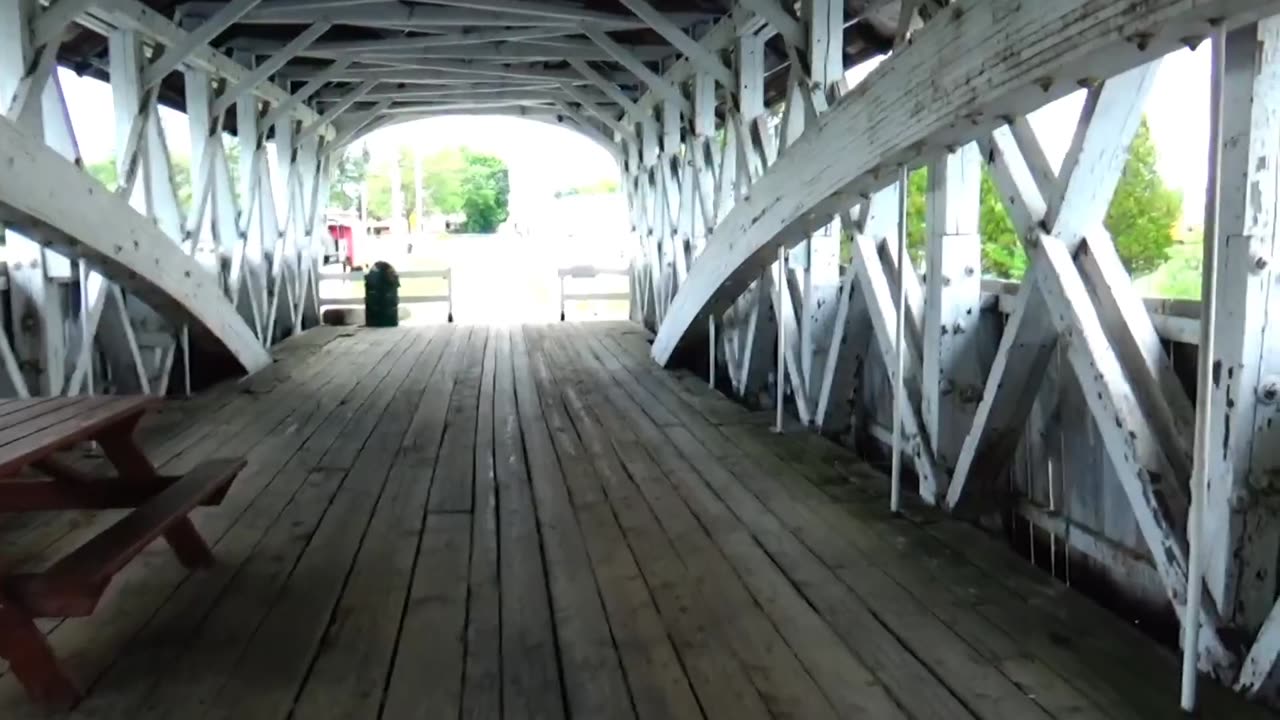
(0, 0), (334, 396)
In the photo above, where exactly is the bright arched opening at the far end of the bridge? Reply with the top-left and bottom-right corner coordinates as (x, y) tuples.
(320, 115), (632, 323)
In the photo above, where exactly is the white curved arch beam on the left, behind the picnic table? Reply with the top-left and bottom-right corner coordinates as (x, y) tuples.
(0, 118), (271, 373)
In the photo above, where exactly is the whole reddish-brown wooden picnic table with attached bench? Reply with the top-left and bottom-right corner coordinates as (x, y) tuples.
(0, 396), (244, 707)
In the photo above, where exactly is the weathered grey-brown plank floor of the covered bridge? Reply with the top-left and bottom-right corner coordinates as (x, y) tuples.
(0, 324), (1262, 720)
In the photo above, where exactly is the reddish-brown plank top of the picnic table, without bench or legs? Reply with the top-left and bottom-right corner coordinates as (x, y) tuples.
(0, 395), (160, 478)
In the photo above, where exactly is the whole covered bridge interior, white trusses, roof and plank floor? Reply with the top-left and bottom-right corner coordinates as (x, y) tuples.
(0, 0), (1280, 720)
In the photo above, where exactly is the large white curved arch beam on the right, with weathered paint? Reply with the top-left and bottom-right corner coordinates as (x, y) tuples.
(653, 0), (1280, 365)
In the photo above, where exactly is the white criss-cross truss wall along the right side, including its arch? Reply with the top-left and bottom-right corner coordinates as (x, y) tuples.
(623, 0), (1280, 692)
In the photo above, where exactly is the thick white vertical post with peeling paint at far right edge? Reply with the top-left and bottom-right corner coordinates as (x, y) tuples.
(1204, 19), (1280, 632)
